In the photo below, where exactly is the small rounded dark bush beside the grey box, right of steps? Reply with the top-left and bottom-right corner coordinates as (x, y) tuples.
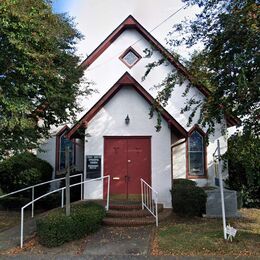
(171, 179), (207, 217)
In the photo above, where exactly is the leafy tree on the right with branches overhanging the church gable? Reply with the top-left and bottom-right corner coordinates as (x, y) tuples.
(145, 0), (260, 135)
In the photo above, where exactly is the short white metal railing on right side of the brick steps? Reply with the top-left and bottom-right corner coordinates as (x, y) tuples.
(140, 178), (159, 227)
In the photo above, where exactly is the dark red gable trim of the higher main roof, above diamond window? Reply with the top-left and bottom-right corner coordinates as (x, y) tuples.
(80, 15), (240, 126)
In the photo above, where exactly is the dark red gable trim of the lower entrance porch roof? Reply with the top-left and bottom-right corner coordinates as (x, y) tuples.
(67, 72), (187, 139)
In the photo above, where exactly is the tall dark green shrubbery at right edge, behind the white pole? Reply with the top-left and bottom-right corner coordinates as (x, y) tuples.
(226, 134), (260, 208)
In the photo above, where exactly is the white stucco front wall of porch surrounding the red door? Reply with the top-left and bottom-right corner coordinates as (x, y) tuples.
(85, 86), (171, 207)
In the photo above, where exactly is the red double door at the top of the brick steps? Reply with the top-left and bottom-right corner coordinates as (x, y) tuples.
(104, 137), (151, 199)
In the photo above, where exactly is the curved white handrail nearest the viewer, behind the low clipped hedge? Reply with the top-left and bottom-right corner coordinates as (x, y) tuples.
(20, 175), (110, 248)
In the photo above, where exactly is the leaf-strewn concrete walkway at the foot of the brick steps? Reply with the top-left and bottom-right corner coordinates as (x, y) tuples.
(0, 222), (154, 259)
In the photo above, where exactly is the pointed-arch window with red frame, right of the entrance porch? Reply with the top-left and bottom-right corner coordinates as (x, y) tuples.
(188, 128), (206, 178)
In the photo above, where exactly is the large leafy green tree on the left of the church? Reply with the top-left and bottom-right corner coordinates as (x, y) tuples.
(0, 0), (91, 159)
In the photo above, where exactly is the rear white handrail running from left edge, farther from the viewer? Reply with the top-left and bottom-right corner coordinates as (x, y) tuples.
(0, 173), (83, 218)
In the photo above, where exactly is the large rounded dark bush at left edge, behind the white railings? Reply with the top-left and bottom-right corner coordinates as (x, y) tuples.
(0, 152), (53, 195)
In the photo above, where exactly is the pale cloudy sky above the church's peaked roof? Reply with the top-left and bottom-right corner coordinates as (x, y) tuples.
(53, 0), (198, 59)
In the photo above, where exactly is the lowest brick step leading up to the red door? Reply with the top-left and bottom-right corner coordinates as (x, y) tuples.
(103, 209), (172, 227)
